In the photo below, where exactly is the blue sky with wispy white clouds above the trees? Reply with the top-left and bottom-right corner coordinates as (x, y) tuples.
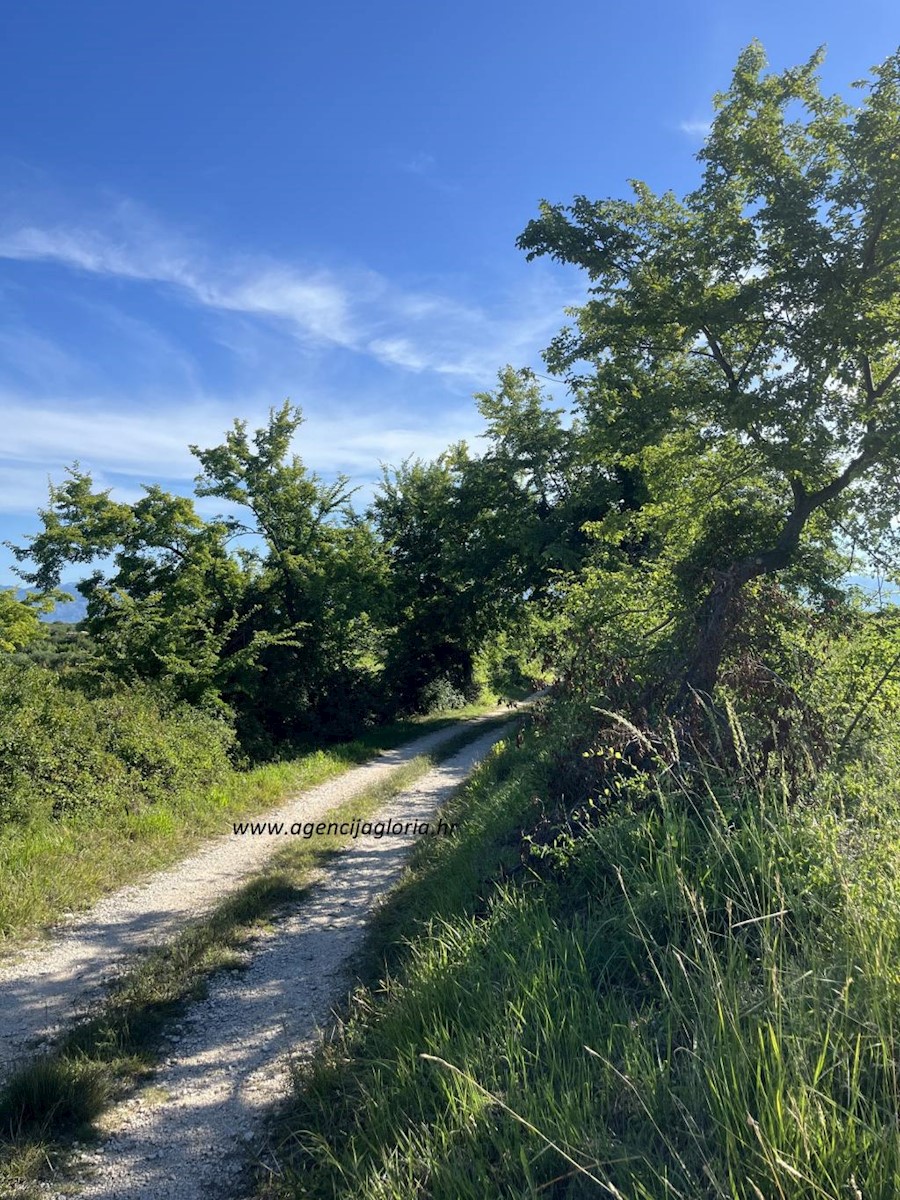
(0, 0), (900, 582)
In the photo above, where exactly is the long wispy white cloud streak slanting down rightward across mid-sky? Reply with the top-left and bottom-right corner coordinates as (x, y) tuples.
(0, 204), (568, 385)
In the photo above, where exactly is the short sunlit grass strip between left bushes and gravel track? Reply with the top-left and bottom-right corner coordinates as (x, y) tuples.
(0, 703), (508, 952)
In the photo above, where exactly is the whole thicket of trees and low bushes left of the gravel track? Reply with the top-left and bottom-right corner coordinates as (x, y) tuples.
(0, 370), (578, 821)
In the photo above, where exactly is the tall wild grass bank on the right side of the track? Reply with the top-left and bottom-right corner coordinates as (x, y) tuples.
(259, 705), (900, 1200)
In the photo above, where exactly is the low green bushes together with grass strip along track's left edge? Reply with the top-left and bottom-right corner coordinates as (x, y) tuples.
(0, 665), (508, 950)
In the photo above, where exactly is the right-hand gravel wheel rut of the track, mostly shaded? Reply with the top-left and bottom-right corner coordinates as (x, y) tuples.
(58, 730), (503, 1200)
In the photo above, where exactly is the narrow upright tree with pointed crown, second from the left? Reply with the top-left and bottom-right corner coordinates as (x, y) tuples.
(191, 402), (385, 738)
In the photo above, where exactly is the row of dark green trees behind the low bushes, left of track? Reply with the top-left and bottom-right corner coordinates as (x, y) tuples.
(0, 384), (571, 756)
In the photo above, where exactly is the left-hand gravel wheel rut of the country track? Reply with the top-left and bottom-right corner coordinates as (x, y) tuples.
(0, 714), (511, 1079)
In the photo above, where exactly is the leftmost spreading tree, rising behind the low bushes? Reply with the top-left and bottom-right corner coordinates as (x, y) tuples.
(12, 464), (268, 703)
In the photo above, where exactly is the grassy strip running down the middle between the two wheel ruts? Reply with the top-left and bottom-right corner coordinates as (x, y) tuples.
(0, 718), (505, 1196)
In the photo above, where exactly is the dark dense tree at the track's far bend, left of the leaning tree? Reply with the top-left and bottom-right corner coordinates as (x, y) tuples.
(372, 366), (607, 707)
